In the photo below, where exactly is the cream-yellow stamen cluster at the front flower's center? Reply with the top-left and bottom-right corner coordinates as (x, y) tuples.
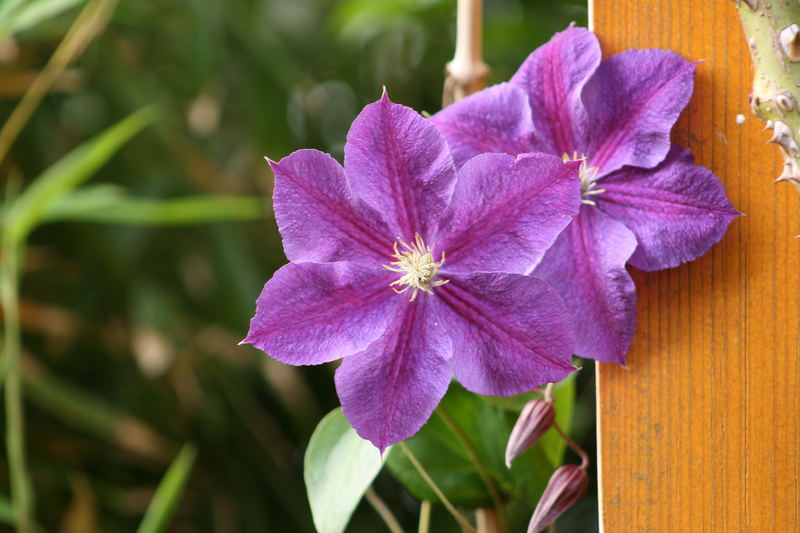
(383, 233), (450, 302)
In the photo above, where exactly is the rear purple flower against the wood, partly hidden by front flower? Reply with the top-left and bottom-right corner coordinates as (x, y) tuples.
(433, 27), (738, 363)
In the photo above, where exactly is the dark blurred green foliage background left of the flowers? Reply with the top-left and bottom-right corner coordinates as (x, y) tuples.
(0, 0), (596, 533)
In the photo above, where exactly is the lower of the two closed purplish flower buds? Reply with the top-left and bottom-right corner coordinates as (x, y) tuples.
(528, 465), (589, 533)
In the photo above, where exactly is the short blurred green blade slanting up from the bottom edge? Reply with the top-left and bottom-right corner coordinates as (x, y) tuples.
(136, 444), (197, 533)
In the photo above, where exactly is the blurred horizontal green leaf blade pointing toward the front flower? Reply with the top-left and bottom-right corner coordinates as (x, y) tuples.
(45, 185), (264, 226)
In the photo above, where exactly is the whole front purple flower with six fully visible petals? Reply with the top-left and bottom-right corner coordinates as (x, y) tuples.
(244, 94), (580, 450)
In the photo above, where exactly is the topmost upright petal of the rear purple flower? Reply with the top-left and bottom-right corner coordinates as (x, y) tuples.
(511, 27), (600, 156)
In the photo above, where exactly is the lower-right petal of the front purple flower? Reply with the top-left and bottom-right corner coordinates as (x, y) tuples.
(431, 272), (575, 396)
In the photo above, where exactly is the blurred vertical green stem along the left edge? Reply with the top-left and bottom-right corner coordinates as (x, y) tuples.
(0, 242), (33, 533)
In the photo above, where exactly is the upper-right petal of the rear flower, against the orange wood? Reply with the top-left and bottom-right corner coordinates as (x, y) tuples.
(583, 50), (695, 176)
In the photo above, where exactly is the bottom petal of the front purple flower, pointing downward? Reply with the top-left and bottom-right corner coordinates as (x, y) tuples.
(336, 294), (452, 453)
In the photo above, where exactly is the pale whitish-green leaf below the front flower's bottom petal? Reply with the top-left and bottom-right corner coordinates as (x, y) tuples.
(304, 408), (383, 533)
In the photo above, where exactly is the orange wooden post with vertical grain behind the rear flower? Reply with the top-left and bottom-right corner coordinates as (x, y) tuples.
(593, 0), (800, 533)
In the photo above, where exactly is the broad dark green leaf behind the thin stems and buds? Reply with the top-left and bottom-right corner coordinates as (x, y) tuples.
(387, 376), (574, 509)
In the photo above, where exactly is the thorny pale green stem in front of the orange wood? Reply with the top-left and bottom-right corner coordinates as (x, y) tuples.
(734, 0), (800, 191)
